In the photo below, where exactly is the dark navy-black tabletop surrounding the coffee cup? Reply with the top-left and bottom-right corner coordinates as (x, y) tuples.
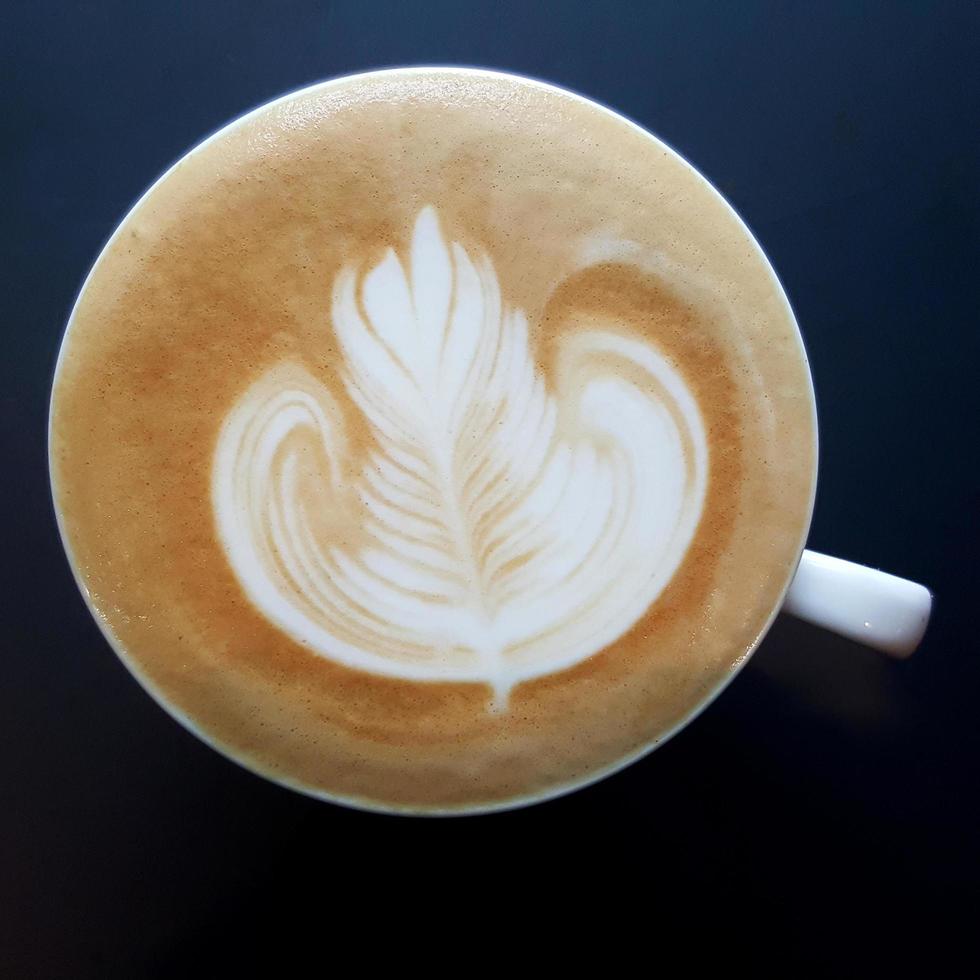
(0, 0), (980, 977)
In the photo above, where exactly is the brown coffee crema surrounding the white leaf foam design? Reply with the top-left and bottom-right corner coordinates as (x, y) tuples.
(50, 69), (816, 812)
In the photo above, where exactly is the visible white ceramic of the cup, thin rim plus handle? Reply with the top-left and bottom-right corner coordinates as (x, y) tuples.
(49, 66), (932, 815)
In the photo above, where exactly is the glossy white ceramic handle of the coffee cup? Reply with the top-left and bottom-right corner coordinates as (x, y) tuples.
(783, 551), (932, 658)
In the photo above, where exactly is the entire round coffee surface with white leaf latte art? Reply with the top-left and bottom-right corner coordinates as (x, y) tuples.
(50, 69), (815, 812)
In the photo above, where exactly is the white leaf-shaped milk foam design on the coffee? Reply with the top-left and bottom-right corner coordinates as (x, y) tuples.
(212, 208), (708, 710)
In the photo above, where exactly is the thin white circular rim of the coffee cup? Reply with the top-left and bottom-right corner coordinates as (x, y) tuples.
(46, 64), (820, 817)
